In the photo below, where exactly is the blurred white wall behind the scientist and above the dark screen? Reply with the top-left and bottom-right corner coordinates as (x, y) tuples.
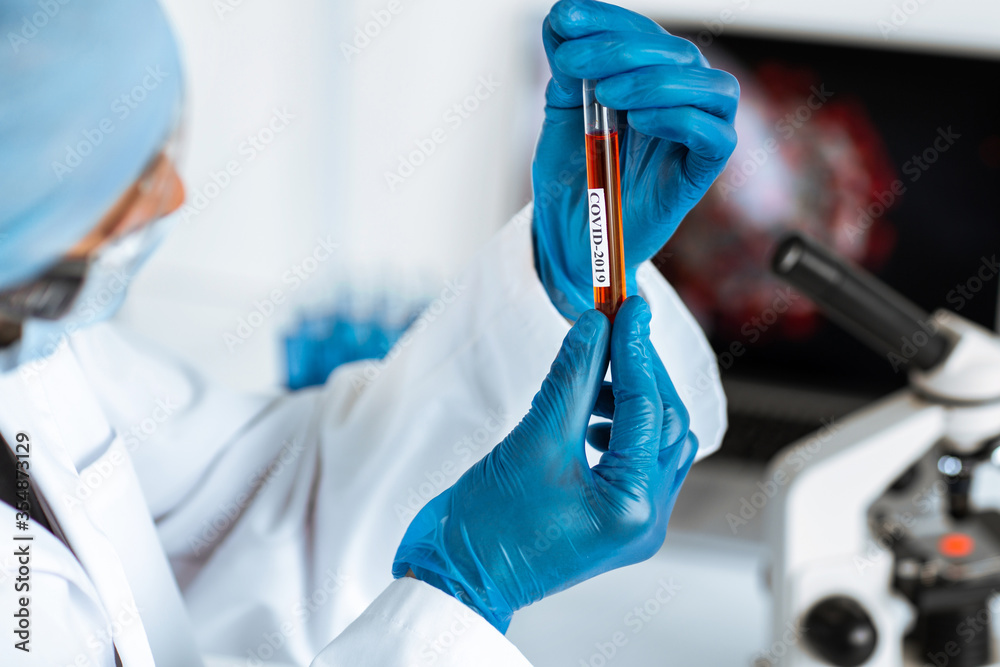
(121, 0), (1000, 390)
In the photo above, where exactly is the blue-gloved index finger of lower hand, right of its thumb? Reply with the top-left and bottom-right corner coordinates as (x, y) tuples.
(594, 296), (663, 491)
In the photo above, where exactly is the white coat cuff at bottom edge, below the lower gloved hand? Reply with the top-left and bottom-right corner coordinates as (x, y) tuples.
(312, 578), (530, 667)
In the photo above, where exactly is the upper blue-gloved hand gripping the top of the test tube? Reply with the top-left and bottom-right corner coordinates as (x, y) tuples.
(532, 0), (739, 319)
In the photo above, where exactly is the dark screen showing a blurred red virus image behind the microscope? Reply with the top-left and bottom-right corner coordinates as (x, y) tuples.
(655, 30), (1000, 395)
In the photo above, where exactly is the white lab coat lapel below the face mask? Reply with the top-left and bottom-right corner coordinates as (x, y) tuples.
(0, 340), (201, 667)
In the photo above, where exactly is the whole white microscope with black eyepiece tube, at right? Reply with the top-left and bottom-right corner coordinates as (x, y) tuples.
(758, 234), (1000, 667)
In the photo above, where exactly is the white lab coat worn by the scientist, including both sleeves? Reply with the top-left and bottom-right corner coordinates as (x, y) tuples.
(0, 213), (725, 667)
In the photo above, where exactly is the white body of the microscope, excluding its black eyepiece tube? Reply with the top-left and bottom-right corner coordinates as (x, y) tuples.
(765, 311), (1000, 667)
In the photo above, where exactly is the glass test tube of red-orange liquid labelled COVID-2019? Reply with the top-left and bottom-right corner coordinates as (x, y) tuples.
(583, 79), (625, 322)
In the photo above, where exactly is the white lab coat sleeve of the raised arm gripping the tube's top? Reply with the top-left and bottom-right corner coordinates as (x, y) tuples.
(76, 206), (725, 665)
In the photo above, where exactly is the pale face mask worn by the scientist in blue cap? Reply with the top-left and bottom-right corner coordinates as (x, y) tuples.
(0, 216), (176, 371)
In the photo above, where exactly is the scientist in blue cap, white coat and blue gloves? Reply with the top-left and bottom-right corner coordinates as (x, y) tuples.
(0, 0), (738, 667)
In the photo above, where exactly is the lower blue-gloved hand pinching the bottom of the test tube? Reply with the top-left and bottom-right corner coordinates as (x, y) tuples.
(392, 296), (698, 632)
